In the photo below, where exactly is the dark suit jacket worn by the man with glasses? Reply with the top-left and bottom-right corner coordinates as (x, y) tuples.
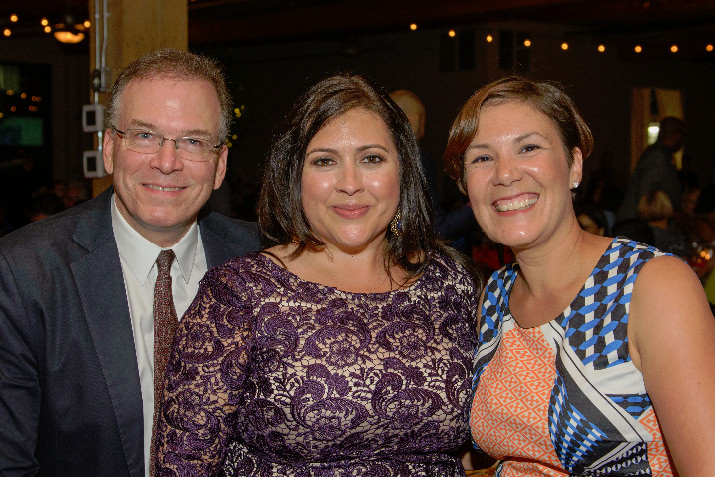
(0, 189), (260, 477)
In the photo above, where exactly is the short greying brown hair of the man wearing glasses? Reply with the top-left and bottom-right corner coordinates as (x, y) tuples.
(107, 48), (233, 141)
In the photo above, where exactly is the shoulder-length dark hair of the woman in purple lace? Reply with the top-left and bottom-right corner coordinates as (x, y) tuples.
(258, 73), (454, 277)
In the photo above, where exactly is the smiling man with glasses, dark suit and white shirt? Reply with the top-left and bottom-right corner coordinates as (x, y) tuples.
(0, 50), (260, 477)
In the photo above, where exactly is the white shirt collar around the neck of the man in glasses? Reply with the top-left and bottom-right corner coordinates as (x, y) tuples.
(112, 194), (199, 283)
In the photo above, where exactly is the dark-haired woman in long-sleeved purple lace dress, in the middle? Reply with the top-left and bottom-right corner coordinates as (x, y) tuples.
(155, 75), (481, 477)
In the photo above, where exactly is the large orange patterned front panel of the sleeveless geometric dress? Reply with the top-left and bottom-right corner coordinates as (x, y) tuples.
(470, 328), (563, 475)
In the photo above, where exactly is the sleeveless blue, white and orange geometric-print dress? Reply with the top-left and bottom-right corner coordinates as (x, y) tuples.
(470, 238), (674, 476)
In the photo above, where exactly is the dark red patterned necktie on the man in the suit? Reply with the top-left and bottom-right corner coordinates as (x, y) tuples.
(149, 249), (178, 475)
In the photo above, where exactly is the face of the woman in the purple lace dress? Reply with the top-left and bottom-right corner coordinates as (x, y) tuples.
(301, 108), (400, 252)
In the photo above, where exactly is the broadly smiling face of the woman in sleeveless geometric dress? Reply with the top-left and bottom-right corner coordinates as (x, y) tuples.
(464, 101), (582, 249)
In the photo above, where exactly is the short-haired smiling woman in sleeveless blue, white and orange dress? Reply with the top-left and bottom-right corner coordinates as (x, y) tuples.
(445, 77), (715, 476)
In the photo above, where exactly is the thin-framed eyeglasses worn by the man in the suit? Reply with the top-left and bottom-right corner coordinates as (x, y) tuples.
(112, 128), (222, 162)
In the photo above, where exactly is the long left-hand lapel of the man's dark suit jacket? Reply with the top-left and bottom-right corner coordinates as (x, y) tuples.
(71, 189), (144, 476)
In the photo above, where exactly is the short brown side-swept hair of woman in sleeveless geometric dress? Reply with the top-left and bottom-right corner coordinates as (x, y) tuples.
(444, 76), (593, 192)
